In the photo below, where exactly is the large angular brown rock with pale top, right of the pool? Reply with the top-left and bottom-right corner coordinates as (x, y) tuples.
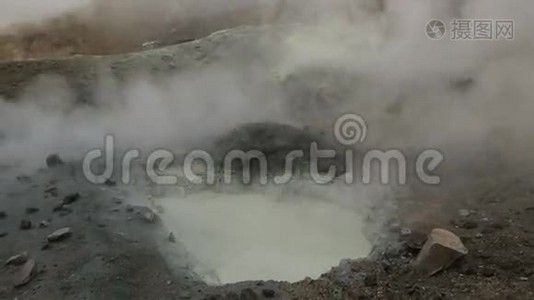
(414, 229), (468, 276)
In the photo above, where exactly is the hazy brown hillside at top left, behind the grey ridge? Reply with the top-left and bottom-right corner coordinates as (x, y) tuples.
(0, 0), (273, 61)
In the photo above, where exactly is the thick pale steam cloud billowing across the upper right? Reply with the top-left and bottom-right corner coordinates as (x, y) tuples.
(279, 0), (533, 156)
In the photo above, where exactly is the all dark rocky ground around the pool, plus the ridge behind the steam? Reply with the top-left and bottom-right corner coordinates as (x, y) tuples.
(0, 29), (534, 299)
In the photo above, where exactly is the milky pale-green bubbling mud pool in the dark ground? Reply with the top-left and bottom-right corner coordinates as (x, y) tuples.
(157, 192), (371, 284)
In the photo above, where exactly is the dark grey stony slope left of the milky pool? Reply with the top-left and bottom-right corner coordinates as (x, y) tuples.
(0, 165), (193, 299)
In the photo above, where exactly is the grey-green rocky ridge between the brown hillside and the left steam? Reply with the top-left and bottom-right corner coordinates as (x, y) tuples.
(0, 27), (280, 103)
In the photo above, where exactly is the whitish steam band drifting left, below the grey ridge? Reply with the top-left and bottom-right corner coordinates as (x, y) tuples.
(0, 66), (289, 168)
